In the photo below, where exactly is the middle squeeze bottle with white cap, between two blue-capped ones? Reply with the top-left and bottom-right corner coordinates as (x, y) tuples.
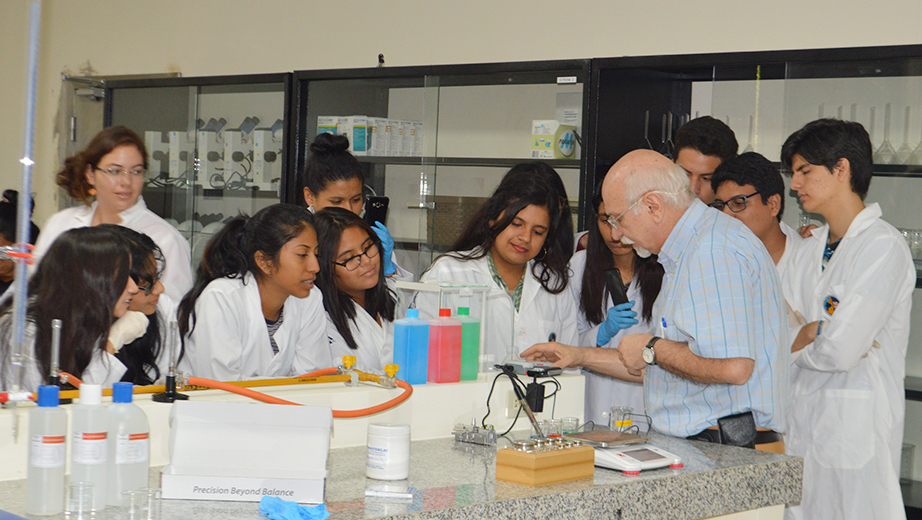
(70, 383), (109, 511)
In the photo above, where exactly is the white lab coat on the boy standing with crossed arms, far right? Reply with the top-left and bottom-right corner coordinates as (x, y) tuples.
(784, 203), (916, 520)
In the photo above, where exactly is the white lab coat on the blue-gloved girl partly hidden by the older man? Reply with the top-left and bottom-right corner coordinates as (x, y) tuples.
(567, 250), (650, 426)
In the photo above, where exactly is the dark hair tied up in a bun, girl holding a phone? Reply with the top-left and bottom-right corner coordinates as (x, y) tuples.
(298, 133), (365, 202)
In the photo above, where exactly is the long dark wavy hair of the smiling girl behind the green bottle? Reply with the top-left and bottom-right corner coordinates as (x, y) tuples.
(436, 162), (573, 294)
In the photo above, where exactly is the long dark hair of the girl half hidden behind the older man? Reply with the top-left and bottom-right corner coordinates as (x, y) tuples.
(579, 183), (665, 325)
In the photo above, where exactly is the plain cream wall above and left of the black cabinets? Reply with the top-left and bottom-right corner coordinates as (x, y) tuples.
(0, 0), (922, 222)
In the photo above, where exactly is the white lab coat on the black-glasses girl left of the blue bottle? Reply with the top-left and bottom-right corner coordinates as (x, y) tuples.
(327, 304), (394, 374)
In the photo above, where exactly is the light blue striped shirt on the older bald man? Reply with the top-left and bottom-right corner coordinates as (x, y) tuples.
(644, 200), (790, 437)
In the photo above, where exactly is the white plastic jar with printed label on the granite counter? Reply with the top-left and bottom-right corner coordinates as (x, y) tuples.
(365, 423), (410, 480)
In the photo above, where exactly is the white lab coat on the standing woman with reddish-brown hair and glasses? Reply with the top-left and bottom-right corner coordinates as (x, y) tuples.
(30, 197), (192, 301)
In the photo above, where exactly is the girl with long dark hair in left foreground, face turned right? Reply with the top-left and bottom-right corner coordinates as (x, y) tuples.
(0, 228), (138, 392)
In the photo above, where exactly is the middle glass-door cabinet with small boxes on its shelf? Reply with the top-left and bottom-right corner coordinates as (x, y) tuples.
(286, 60), (590, 276)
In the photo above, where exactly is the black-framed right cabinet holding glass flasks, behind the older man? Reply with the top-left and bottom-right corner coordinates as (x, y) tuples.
(584, 45), (922, 512)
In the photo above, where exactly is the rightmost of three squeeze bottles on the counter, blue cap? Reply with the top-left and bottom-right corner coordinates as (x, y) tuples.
(106, 383), (150, 506)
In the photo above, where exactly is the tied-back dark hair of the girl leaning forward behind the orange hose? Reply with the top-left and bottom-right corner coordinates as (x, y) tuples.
(178, 204), (314, 346)
